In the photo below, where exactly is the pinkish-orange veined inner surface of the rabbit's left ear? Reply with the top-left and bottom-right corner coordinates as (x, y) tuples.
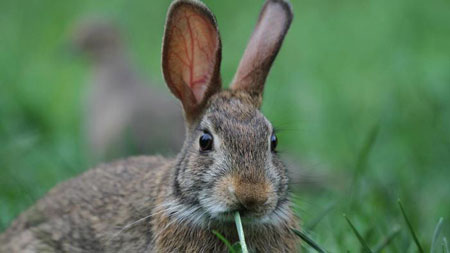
(168, 9), (219, 103)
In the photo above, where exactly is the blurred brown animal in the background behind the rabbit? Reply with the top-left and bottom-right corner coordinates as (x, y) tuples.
(72, 20), (185, 160)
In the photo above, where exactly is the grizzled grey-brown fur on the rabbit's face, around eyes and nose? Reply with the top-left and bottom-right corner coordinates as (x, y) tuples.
(176, 94), (287, 222)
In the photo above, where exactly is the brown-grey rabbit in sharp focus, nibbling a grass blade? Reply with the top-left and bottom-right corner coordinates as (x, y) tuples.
(0, 0), (299, 252)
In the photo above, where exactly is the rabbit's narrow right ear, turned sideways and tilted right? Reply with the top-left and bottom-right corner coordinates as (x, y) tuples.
(231, 0), (293, 107)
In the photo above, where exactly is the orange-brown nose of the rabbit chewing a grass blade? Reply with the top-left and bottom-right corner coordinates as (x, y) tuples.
(234, 183), (269, 211)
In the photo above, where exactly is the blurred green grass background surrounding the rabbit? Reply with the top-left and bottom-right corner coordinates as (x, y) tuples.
(0, 0), (450, 252)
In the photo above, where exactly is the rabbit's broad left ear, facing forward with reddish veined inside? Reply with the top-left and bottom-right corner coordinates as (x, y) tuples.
(162, 0), (221, 121)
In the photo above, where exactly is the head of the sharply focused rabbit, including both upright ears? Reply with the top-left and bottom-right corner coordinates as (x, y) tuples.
(162, 0), (292, 223)
